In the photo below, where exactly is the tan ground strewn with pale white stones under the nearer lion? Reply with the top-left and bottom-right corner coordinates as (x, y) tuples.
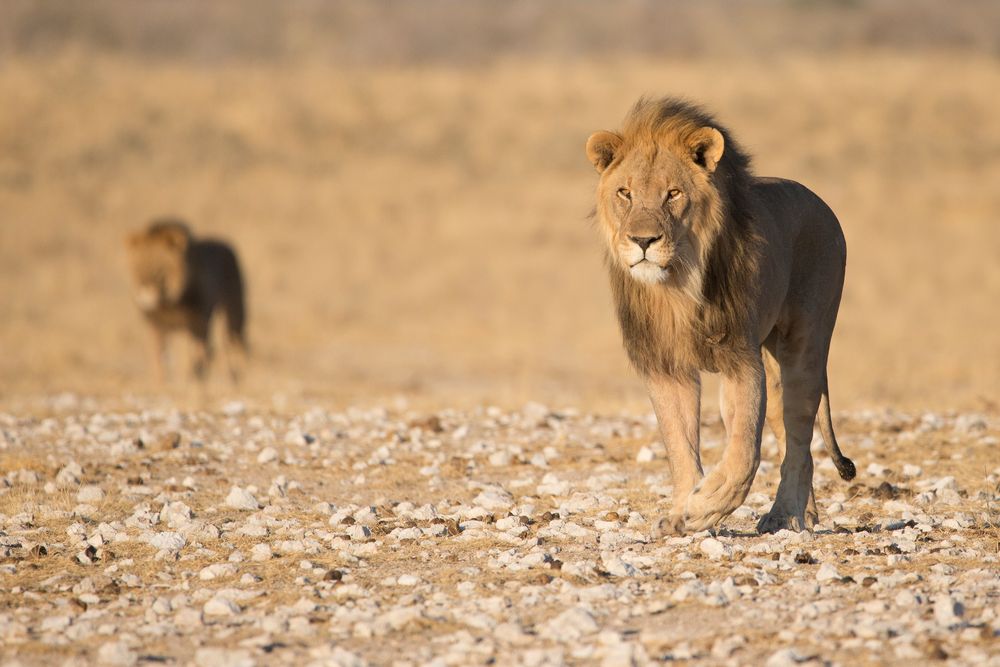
(0, 396), (1000, 667)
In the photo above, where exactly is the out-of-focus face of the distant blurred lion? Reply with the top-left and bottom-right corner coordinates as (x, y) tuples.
(126, 224), (188, 312)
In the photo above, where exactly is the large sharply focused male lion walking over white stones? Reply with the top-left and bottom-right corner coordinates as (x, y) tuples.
(586, 98), (856, 534)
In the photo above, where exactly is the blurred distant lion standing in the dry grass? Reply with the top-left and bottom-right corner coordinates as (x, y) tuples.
(126, 218), (247, 383)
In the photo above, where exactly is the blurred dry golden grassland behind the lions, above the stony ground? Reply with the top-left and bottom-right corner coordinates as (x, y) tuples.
(0, 0), (1000, 411)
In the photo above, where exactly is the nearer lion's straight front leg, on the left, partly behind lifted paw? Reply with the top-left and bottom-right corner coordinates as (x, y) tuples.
(646, 372), (703, 534)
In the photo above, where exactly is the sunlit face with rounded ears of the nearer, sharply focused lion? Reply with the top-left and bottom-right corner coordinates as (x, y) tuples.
(587, 128), (722, 283)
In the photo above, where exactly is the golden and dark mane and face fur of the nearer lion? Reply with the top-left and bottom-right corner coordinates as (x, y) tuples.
(597, 99), (761, 375)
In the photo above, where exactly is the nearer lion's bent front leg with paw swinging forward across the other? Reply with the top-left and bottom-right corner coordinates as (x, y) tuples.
(684, 357), (766, 531)
